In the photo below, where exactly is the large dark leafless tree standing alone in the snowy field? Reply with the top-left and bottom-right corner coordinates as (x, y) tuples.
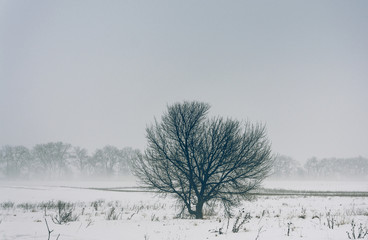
(133, 102), (273, 219)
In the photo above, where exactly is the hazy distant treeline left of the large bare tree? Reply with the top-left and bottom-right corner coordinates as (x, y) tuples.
(0, 142), (139, 179)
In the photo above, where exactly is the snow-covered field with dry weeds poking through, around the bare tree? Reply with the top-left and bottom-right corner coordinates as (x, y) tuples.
(0, 180), (368, 240)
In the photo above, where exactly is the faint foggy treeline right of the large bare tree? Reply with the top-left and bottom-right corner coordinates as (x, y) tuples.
(272, 155), (368, 179)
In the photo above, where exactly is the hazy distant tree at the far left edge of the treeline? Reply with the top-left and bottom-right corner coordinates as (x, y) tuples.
(0, 145), (32, 178)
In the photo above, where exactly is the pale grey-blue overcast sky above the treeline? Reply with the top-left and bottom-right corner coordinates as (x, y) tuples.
(0, 0), (368, 161)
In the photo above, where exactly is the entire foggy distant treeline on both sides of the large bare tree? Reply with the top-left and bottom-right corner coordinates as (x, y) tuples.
(0, 142), (368, 179)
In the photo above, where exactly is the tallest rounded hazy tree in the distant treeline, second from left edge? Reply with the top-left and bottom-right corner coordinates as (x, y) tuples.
(32, 142), (71, 178)
